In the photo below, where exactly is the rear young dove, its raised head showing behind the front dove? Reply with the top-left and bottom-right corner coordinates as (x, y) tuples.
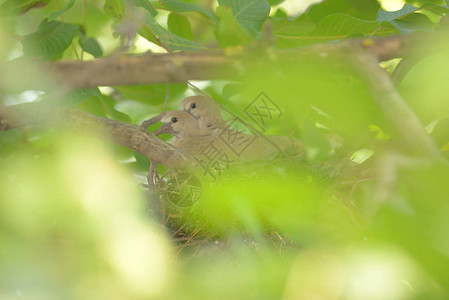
(181, 95), (304, 154)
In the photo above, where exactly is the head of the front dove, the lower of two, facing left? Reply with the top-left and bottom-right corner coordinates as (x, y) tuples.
(154, 110), (200, 138)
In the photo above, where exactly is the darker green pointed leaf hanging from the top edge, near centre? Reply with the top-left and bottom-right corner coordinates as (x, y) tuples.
(218, 0), (271, 36)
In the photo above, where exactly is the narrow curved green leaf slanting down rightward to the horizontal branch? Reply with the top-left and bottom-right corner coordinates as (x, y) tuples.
(145, 13), (208, 51)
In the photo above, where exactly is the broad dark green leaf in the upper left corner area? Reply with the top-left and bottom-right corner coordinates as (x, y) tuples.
(22, 20), (78, 60)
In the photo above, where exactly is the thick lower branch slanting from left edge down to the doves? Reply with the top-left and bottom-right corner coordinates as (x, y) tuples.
(0, 103), (191, 168)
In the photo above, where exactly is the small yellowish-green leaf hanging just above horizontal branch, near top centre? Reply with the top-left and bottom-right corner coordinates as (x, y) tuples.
(215, 7), (253, 48)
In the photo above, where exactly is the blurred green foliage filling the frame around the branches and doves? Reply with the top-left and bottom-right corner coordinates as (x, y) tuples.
(0, 0), (449, 299)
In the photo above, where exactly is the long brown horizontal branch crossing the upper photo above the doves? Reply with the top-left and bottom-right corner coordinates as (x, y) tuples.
(0, 35), (436, 89)
